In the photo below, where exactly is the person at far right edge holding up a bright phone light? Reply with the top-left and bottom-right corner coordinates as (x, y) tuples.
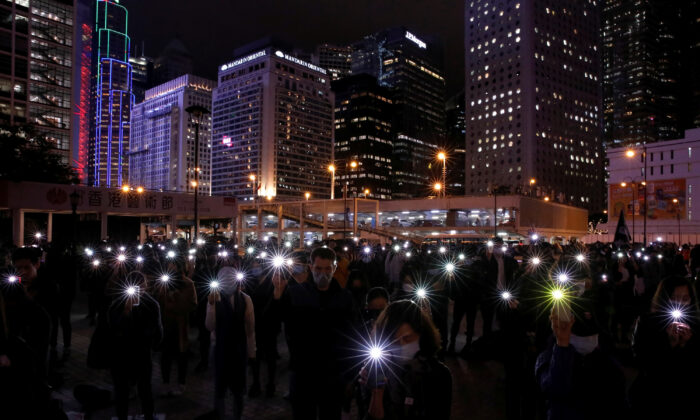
(630, 276), (700, 418)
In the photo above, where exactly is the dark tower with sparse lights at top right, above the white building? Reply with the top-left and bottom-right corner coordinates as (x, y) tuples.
(601, 0), (684, 146)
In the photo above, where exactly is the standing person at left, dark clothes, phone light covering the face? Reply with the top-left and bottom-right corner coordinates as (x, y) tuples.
(107, 271), (163, 420)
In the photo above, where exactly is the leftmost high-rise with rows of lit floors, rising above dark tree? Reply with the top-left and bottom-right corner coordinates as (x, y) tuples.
(0, 0), (74, 163)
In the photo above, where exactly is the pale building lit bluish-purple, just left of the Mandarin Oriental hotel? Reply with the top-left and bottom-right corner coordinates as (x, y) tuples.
(129, 74), (216, 194)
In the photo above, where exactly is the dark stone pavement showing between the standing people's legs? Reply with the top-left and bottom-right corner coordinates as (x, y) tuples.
(53, 296), (505, 420)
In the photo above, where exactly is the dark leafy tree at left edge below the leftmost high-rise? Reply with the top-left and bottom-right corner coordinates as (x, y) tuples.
(0, 125), (79, 184)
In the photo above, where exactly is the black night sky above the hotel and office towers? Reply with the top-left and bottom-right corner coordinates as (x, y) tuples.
(122, 0), (464, 96)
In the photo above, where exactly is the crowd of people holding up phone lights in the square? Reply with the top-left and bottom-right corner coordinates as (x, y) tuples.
(0, 236), (700, 420)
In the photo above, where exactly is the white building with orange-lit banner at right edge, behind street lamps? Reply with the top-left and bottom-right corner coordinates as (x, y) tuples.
(607, 128), (700, 243)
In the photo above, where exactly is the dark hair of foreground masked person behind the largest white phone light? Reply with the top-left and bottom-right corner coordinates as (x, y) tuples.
(375, 300), (440, 357)
